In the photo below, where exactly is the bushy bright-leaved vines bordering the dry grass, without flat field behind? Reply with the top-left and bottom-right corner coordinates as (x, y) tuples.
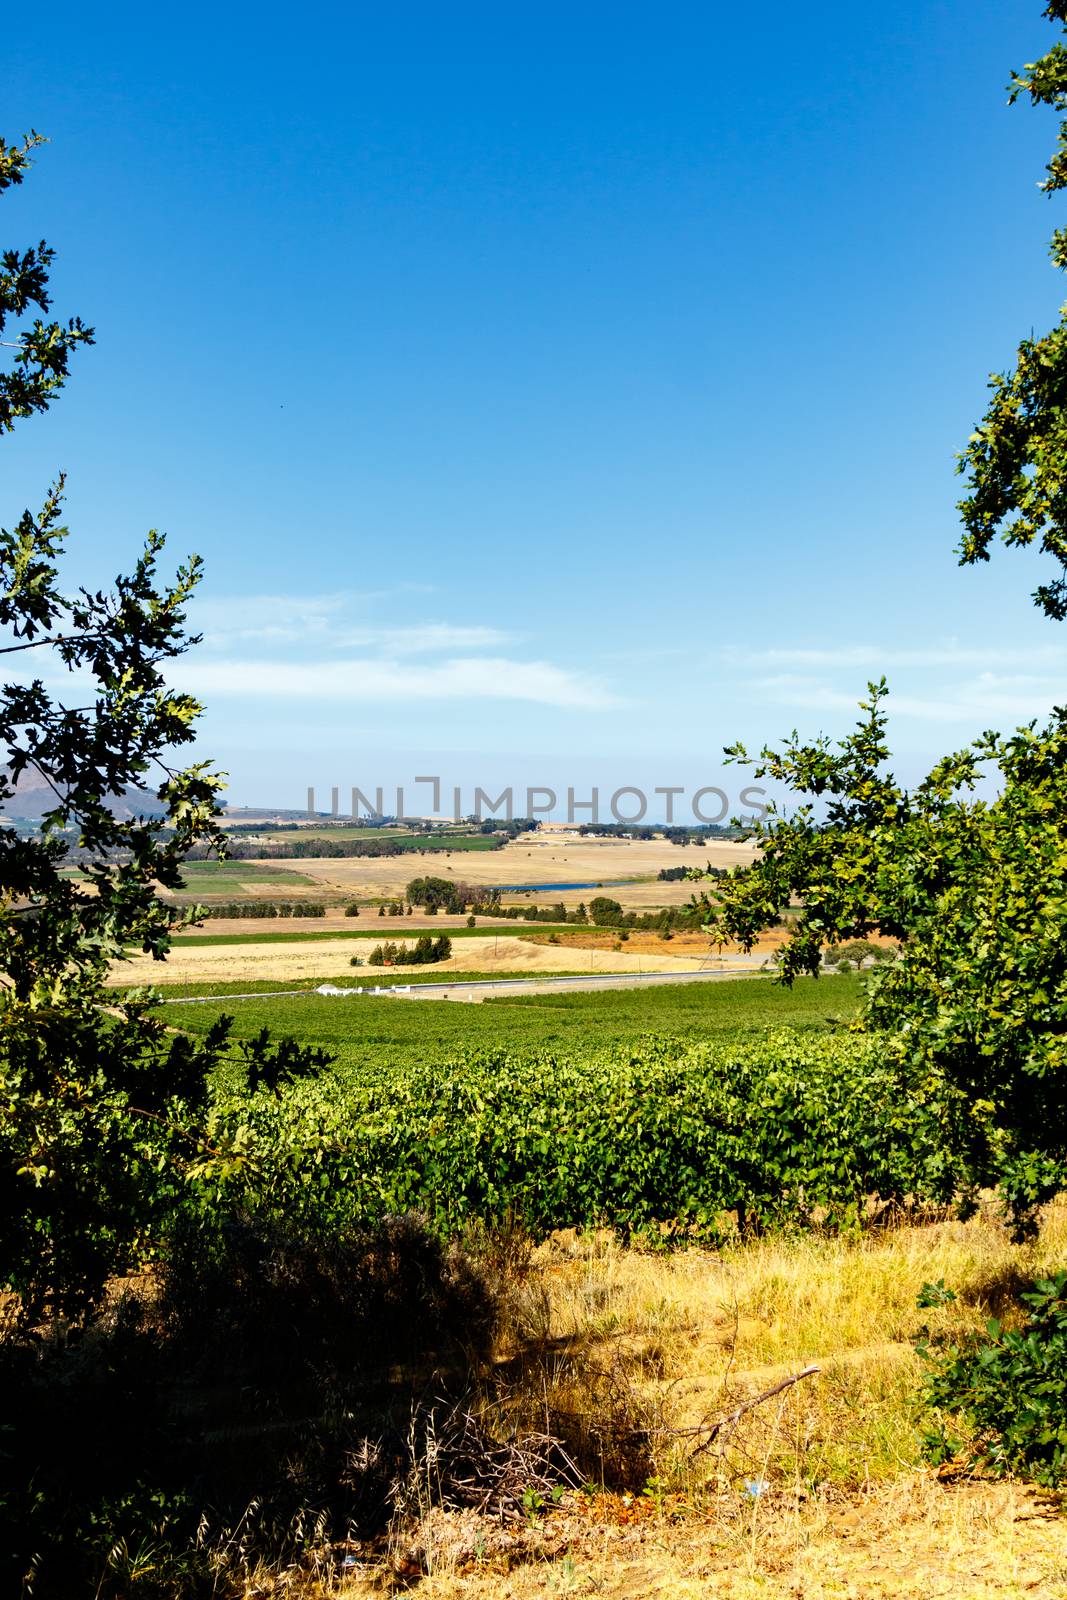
(199, 1032), (958, 1238)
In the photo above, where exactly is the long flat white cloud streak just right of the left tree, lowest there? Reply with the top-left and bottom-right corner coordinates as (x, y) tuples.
(181, 656), (621, 710)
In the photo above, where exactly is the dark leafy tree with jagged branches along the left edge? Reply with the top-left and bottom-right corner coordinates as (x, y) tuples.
(0, 136), (226, 1317)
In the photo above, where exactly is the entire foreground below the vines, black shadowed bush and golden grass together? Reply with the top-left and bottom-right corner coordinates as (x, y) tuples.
(0, 1208), (1067, 1600)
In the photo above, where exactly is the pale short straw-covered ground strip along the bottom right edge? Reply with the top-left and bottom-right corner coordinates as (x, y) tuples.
(374, 1474), (1067, 1600)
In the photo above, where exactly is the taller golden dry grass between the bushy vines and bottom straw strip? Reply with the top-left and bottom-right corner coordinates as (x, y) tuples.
(495, 1208), (1067, 1490)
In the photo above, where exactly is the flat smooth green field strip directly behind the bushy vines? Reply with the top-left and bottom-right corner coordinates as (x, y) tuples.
(168, 970), (862, 1072)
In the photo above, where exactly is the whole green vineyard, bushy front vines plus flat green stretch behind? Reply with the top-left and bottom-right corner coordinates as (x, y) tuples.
(127, 978), (957, 1235)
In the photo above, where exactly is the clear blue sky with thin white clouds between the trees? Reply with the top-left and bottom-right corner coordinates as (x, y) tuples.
(0, 0), (1067, 805)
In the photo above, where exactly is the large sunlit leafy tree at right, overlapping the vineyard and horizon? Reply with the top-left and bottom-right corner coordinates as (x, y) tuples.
(702, 682), (1067, 1213)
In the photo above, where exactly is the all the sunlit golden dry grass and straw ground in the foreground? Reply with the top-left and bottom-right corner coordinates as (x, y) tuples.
(338, 1206), (1067, 1600)
